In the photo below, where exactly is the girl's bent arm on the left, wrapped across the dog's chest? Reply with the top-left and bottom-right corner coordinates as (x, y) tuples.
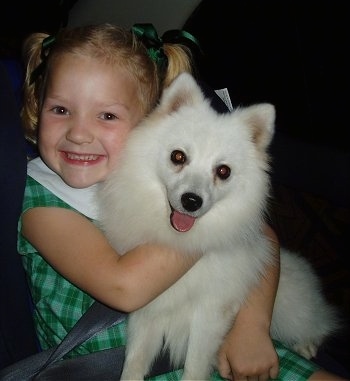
(22, 207), (198, 312)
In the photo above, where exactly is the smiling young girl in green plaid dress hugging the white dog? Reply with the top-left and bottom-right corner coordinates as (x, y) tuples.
(18, 24), (338, 380)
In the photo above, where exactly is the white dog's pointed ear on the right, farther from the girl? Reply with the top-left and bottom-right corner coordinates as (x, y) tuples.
(240, 103), (276, 152)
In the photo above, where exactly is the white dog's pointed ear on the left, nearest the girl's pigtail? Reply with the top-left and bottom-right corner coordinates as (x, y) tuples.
(158, 73), (204, 114)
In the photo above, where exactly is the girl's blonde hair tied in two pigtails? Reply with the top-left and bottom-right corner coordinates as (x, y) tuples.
(22, 24), (192, 144)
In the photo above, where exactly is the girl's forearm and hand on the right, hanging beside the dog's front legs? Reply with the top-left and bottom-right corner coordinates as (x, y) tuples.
(218, 225), (280, 380)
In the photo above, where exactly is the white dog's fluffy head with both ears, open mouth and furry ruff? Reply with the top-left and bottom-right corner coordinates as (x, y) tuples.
(99, 74), (275, 252)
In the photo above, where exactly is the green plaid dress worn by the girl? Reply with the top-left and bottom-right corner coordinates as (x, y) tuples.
(18, 176), (318, 381)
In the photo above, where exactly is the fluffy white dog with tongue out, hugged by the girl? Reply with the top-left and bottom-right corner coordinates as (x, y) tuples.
(98, 74), (337, 380)
